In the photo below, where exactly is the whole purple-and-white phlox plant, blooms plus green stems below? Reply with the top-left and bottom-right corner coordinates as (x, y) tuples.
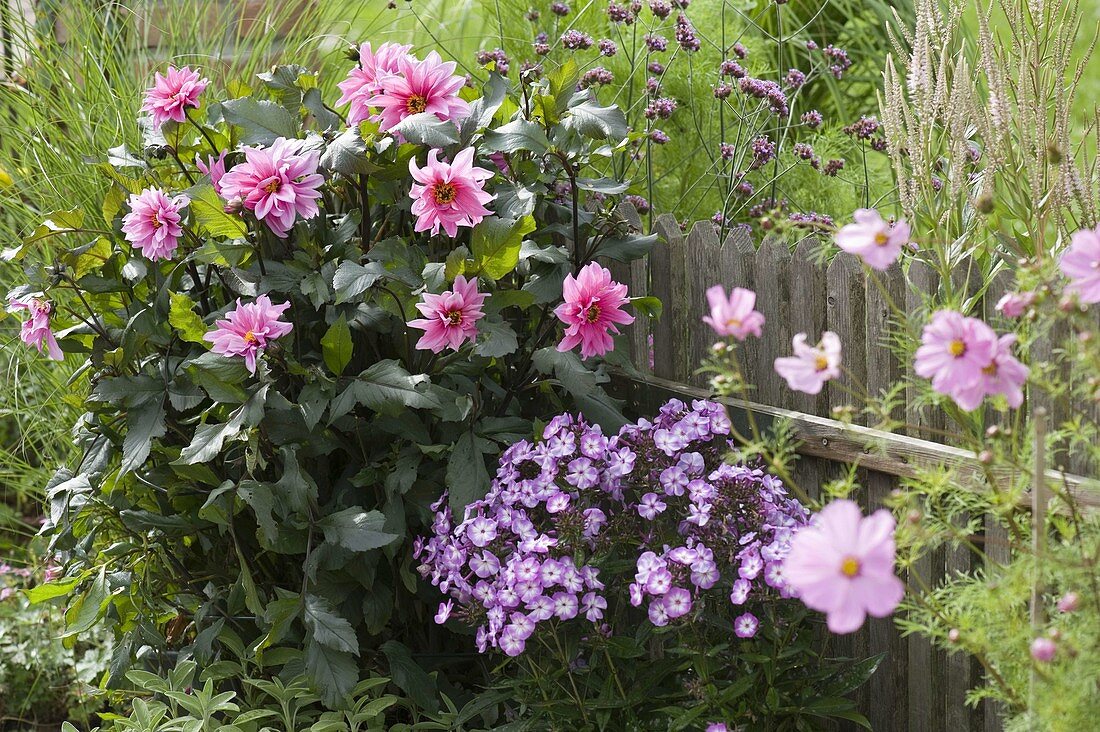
(415, 400), (875, 729)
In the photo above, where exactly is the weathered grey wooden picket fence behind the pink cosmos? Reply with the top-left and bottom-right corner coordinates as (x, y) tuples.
(609, 211), (1100, 732)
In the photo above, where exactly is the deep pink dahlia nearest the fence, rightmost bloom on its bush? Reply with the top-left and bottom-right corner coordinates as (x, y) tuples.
(553, 262), (634, 359)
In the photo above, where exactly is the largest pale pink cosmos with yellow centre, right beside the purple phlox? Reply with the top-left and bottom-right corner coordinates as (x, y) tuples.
(783, 500), (905, 633)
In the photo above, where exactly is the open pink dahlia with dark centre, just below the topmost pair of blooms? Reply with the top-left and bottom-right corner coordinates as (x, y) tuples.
(409, 148), (493, 237)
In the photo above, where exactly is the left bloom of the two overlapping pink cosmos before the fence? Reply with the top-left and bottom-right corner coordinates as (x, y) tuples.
(913, 310), (999, 409)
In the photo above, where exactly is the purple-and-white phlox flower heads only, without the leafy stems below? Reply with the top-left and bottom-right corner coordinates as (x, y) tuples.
(414, 400), (809, 656)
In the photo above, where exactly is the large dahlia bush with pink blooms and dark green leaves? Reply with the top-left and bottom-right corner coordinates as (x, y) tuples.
(4, 44), (659, 709)
